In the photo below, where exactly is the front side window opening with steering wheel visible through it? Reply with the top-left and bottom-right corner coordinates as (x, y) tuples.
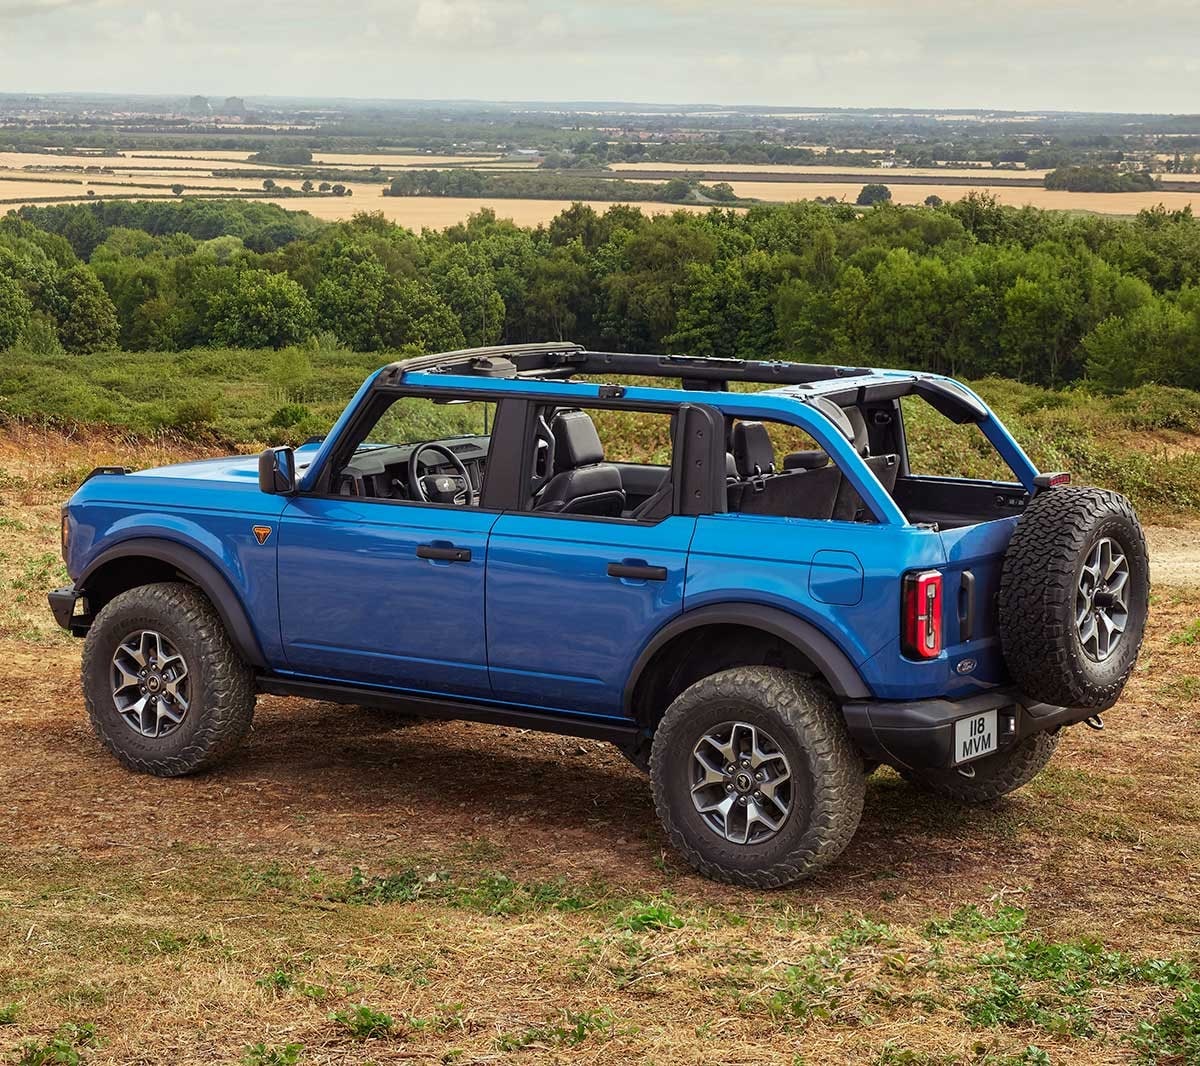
(330, 396), (496, 507)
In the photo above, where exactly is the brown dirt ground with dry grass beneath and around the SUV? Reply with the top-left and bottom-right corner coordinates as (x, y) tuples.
(0, 435), (1200, 1066)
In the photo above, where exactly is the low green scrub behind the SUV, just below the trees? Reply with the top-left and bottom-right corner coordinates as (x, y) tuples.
(0, 346), (1200, 513)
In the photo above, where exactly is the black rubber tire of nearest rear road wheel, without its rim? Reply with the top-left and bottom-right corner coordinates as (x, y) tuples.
(650, 666), (866, 888)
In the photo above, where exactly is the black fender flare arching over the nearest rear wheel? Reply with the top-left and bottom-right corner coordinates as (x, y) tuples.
(624, 603), (871, 714)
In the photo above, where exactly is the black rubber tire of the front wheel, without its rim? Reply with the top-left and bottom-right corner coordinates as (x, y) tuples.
(82, 582), (254, 777)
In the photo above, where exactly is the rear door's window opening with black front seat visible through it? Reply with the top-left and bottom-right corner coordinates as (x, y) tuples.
(527, 405), (673, 521)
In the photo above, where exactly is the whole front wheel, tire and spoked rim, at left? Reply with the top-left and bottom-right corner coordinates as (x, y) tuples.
(83, 583), (254, 777)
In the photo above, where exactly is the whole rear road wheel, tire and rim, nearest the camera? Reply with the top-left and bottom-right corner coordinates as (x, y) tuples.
(650, 666), (866, 888)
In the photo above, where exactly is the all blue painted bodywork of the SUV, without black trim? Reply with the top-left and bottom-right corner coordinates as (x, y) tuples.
(67, 362), (1037, 715)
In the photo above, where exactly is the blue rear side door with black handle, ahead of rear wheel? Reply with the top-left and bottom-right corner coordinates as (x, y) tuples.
(487, 398), (724, 715)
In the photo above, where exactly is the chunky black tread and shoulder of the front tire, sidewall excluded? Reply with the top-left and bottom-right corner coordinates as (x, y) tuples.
(82, 582), (256, 777)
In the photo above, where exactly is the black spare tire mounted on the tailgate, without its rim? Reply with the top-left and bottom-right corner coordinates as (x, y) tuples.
(998, 485), (1148, 709)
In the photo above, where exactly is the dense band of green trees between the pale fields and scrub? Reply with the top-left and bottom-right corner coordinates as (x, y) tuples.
(0, 192), (1200, 390)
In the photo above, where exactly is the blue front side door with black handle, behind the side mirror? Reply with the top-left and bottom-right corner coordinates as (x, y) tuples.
(278, 397), (499, 697)
